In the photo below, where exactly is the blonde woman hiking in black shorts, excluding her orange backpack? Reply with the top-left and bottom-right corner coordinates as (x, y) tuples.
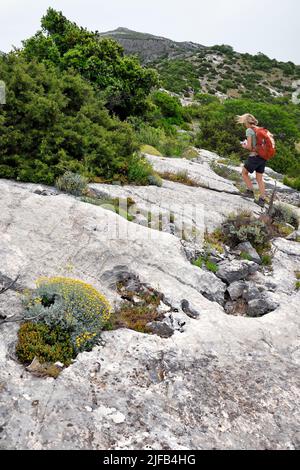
(237, 114), (267, 207)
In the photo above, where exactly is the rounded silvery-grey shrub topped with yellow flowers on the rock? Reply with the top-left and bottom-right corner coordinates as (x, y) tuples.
(24, 277), (111, 353)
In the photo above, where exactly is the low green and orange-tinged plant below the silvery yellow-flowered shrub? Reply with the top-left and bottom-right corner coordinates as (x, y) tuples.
(16, 322), (75, 365)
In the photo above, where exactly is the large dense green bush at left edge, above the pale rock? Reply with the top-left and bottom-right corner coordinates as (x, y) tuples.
(0, 54), (138, 184)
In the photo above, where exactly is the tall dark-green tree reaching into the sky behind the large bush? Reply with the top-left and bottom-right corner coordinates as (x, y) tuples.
(22, 8), (158, 119)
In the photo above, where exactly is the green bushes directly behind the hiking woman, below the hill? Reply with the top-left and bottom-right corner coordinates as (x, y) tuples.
(193, 99), (300, 176)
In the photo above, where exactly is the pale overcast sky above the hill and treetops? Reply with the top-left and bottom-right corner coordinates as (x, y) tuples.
(0, 0), (300, 64)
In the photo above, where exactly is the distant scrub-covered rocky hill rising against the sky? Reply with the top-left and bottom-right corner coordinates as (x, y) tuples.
(100, 28), (300, 103)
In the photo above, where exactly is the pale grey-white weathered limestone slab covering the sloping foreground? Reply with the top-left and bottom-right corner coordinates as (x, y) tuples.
(0, 167), (300, 450)
